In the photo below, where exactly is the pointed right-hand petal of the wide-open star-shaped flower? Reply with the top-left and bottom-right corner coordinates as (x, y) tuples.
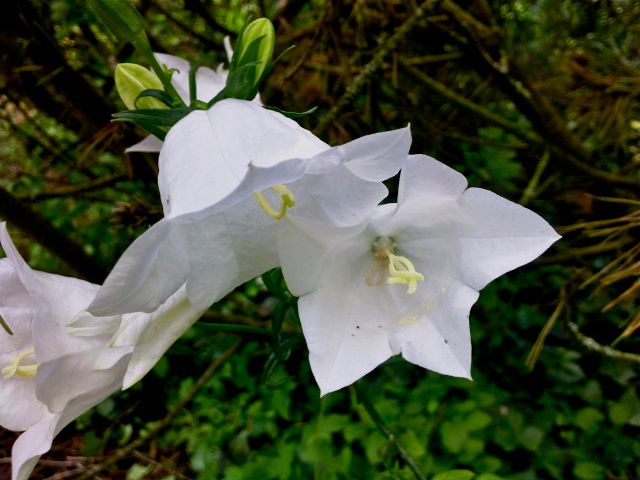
(396, 188), (560, 290)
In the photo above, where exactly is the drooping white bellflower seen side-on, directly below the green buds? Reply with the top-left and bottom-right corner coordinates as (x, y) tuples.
(89, 99), (410, 315)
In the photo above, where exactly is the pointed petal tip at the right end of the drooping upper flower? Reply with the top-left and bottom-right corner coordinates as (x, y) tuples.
(338, 127), (411, 182)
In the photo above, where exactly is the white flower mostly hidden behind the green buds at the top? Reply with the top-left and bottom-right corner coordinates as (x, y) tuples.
(125, 51), (262, 152)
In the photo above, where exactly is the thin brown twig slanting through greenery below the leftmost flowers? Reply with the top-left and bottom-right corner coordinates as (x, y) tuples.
(77, 339), (243, 480)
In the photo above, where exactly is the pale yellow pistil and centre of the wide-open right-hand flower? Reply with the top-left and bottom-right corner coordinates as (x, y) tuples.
(367, 237), (424, 295)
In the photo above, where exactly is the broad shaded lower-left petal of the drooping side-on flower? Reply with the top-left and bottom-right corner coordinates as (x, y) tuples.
(88, 193), (278, 315)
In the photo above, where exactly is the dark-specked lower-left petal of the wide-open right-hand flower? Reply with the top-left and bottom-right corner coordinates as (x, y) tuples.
(299, 241), (396, 395)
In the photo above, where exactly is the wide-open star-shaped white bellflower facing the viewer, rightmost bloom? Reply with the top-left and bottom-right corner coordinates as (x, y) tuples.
(278, 155), (559, 395)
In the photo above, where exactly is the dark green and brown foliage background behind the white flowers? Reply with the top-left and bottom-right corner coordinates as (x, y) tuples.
(0, 0), (640, 480)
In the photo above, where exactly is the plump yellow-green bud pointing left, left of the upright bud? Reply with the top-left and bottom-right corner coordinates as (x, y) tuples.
(115, 63), (167, 110)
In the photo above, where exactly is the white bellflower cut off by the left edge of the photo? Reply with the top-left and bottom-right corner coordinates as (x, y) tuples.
(0, 223), (130, 480)
